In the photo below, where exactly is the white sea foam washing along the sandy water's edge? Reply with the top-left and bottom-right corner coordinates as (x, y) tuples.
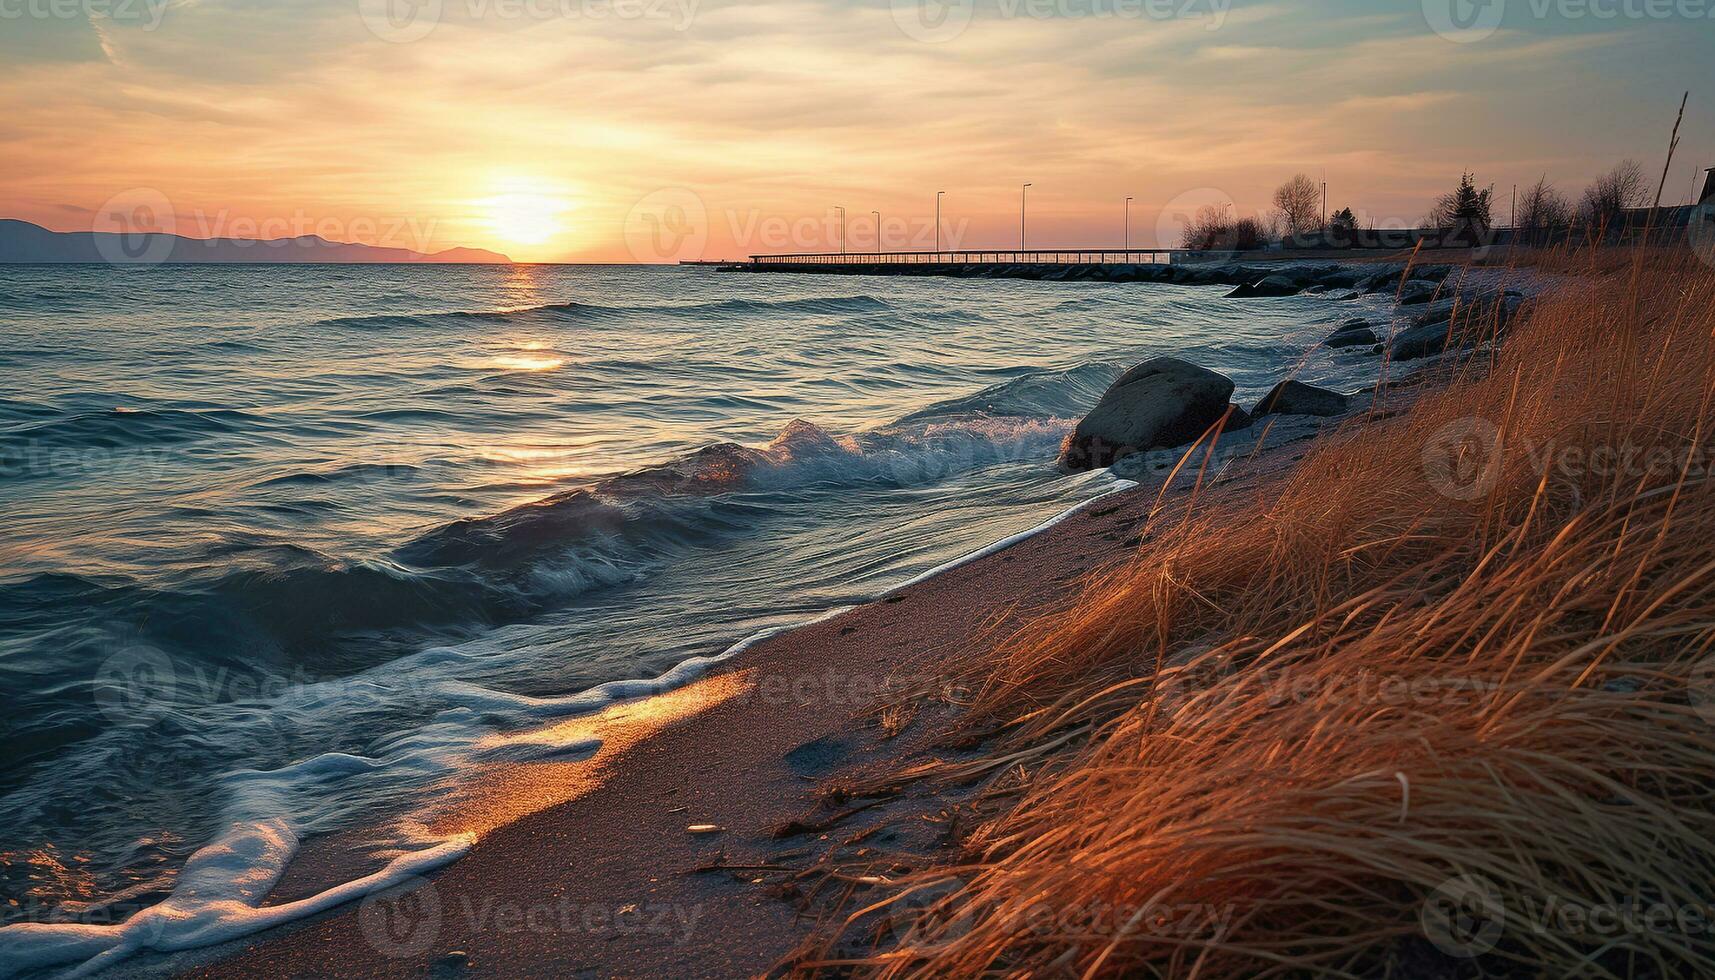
(0, 481), (1137, 977)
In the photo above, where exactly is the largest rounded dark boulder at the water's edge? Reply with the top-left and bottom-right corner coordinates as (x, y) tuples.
(1060, 357), (1233, 470)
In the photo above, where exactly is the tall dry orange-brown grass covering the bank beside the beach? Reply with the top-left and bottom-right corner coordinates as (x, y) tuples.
(799, 254), (1715, 977)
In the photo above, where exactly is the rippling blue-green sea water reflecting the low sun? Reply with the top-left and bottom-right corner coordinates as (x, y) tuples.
(0, 259), (1382, 951)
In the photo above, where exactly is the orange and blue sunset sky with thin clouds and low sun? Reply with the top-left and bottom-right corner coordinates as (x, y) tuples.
(0, 0), (1715, 263)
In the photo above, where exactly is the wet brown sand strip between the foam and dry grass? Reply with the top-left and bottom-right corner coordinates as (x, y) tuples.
(170, 405), (1365, 977)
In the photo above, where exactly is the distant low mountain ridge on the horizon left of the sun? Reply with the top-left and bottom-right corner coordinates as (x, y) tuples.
(0, 218), (511, 264)
